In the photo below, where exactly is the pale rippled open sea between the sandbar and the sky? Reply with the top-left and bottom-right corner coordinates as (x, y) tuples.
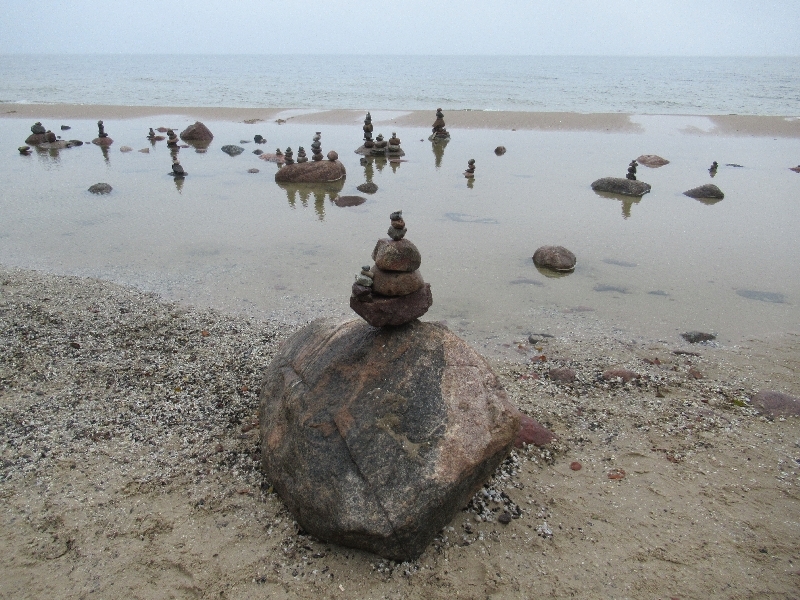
(0, 55), (800, 116)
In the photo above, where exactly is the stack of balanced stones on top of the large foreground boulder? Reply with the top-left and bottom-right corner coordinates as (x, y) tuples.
(350, 211), (433, 327)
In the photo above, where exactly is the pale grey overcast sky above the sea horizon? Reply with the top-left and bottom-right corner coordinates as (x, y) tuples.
(0, 0), (800, 55)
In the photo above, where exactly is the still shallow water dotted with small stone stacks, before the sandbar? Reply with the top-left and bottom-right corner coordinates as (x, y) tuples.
(0, 116), (800, 355)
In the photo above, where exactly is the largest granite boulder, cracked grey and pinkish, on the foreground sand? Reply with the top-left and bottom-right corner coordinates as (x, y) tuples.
(260, 319), (520, 560)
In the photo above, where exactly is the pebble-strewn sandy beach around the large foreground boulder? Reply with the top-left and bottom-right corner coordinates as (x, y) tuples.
(0, 267), (800, 600)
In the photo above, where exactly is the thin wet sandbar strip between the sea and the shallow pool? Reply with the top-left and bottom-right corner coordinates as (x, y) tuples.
(0, 103), (800, 138)
